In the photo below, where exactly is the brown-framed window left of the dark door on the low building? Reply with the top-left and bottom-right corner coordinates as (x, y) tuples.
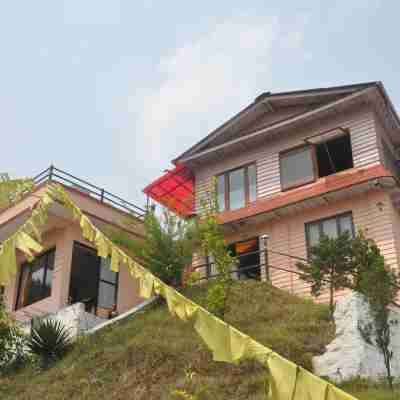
(16, 249), (55, 309)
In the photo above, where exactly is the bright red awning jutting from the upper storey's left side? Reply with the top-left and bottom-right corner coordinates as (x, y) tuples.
(143, 165), (194, 218)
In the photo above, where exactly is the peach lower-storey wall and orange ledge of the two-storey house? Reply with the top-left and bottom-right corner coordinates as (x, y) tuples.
(195, 190), (400, 301)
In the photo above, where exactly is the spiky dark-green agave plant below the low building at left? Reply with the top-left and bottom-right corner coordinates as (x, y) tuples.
(28, 319), (72, 366)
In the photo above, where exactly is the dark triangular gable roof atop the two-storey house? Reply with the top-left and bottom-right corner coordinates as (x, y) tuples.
(173, 82), (381, 163)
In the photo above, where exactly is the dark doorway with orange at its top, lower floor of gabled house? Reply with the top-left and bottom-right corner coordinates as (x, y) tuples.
(229, 237), (261, 280)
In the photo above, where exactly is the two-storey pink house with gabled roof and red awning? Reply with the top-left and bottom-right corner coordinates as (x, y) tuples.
(144, 82), (400, 299)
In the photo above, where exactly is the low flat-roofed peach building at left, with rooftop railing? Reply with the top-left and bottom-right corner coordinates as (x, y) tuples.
(0, 167), (145, 320)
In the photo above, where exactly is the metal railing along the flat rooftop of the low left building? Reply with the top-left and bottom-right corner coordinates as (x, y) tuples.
(33, 165), (146, 219)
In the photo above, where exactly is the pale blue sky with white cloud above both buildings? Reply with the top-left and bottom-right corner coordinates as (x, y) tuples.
(0, 0), (400, 209)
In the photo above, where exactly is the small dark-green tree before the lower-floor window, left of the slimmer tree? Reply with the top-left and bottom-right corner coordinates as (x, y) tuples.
(296, 232), (353, 318)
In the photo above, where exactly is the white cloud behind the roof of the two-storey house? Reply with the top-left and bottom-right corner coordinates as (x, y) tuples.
(120, 15), (309, 185)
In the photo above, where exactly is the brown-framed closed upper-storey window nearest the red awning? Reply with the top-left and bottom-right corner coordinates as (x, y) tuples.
(217, 164), (257, 211)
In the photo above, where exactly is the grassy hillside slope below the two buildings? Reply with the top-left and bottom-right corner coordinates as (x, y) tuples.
(0, 282), (399, 400)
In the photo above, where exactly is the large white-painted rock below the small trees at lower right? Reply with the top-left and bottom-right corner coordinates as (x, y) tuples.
(313, 293), (400, 382)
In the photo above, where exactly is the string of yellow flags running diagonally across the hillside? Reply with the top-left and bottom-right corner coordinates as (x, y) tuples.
(0, 184), (356, 400)
